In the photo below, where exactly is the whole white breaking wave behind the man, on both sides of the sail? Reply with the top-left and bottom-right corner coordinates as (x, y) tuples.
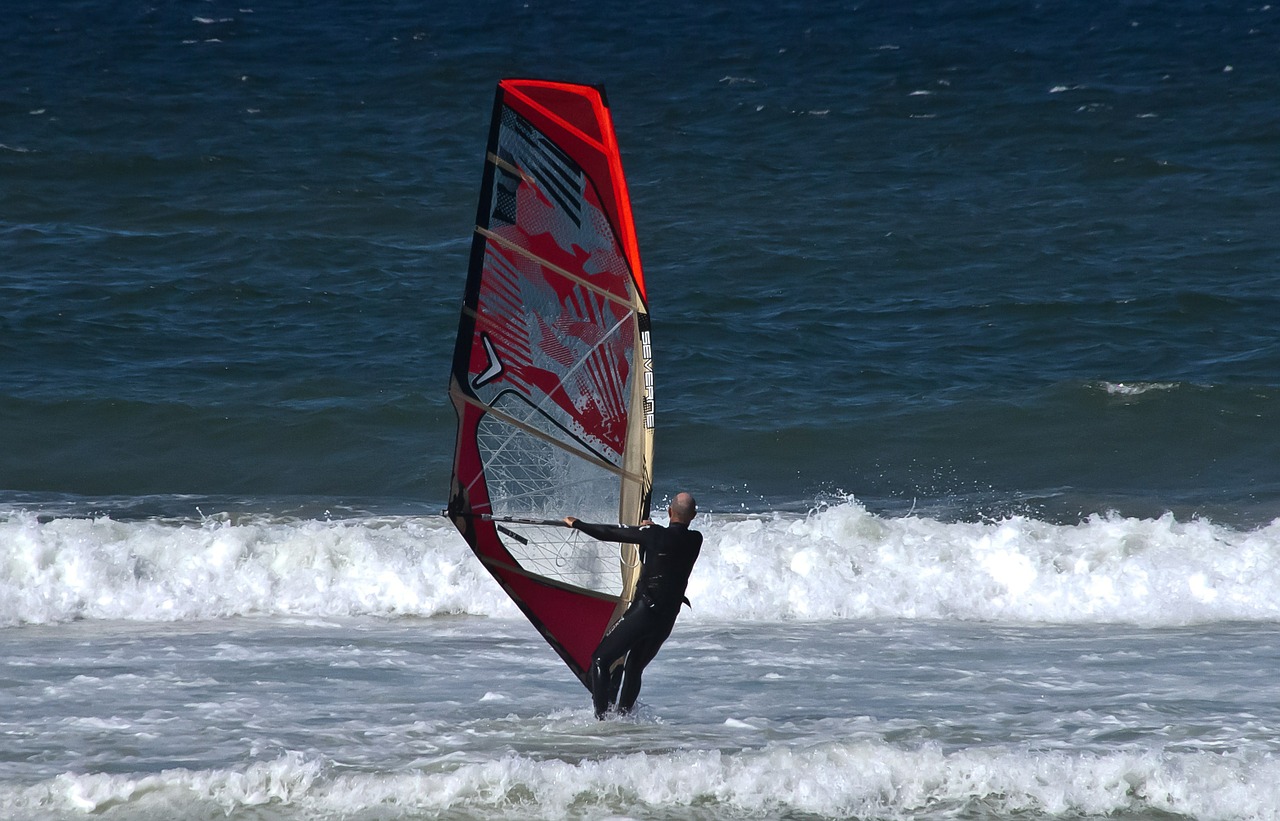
(0, 501), (1280, 626)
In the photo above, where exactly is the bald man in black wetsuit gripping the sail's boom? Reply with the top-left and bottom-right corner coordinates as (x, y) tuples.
(564, 493), (703, 719)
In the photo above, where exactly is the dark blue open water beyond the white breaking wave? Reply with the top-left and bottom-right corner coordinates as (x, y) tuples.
(0, 0), (1280, 526)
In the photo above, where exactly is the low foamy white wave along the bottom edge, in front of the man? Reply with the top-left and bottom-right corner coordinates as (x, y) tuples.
(0, 742), (1280, 820)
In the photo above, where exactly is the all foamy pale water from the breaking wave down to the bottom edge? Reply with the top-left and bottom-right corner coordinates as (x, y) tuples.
(0, 498), (1280, 821)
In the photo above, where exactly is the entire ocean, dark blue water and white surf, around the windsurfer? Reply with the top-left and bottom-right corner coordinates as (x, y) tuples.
(0, 0), (1280, 821)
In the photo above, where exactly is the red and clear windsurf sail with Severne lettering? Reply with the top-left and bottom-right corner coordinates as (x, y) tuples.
(445, 79), (653, 684)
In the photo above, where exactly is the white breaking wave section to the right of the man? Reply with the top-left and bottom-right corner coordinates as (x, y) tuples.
(690, 502), (1280, 625)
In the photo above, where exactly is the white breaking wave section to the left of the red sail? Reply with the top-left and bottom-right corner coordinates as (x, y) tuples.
(0, 514), (517, 625)
